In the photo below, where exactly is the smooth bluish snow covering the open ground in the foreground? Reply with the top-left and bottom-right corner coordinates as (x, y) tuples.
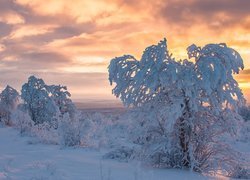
(0, 127), (211, 180)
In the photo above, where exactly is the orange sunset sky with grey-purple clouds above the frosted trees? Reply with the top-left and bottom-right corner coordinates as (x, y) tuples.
(0, 0), (250, 101)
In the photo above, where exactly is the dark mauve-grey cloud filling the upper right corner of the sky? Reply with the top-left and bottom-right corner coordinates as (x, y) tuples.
(159, 0), (250, 30)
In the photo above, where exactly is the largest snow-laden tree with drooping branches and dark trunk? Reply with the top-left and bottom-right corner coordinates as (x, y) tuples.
(109, 39), (245, 174)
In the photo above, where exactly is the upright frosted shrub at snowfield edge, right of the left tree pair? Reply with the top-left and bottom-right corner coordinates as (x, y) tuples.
(58, 113), (82, 146)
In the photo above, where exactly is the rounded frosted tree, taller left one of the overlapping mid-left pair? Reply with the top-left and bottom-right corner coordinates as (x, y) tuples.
(21, 76), (57, 124)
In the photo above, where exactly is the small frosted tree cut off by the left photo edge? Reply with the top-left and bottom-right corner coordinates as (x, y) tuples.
(0, 85), (19, 124)
